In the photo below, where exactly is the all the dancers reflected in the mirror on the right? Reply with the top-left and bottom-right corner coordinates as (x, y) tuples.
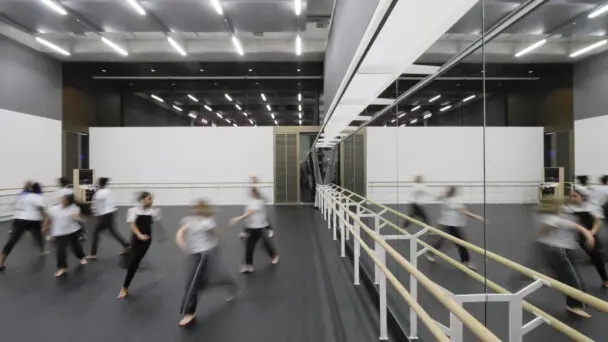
(404, 175), (608, 318)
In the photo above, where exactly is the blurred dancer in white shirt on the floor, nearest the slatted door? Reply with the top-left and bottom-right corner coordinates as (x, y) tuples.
(230, 188), (279, 273)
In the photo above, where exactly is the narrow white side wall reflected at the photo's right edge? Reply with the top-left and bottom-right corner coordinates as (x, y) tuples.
(574, 115), (608, 182)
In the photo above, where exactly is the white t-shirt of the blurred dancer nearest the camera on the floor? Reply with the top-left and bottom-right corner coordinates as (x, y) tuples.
(183, 216), (219, 254)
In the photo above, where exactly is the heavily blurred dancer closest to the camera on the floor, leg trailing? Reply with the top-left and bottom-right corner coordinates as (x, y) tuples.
(175, 200), (238, 326)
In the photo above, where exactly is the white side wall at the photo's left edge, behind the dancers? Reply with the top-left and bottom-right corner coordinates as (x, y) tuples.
(0, 109), (61, 217)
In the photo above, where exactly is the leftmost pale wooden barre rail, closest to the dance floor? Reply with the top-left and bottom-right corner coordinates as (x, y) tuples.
(326, 191), (500, 341)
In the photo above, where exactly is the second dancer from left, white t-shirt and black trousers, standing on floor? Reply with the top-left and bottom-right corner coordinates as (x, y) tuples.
(45, 195), (87, 277)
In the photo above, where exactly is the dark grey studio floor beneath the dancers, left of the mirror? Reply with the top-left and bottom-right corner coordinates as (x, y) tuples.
(0, 206), (384, 342)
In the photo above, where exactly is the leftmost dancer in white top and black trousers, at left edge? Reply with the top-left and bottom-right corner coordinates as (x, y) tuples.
(0, 183), (48, 271)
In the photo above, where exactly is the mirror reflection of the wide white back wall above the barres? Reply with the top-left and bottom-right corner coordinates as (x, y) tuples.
(367, 127), (544, 203)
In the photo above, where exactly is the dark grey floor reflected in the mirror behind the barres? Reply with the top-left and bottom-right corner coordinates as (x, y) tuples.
(350, 204), (608, 342)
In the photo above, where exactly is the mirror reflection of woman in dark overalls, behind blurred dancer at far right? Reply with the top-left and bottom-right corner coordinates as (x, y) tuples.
(563, 187), (608, 287)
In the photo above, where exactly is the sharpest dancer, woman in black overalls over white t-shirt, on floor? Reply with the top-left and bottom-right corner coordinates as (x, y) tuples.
(116, 191), (160, 299)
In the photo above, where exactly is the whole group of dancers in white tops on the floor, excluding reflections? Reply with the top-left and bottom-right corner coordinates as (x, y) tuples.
(0, 177), (279, 326)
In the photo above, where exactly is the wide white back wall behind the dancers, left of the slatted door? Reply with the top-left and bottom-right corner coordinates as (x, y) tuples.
(89, 127), (274, 205)
